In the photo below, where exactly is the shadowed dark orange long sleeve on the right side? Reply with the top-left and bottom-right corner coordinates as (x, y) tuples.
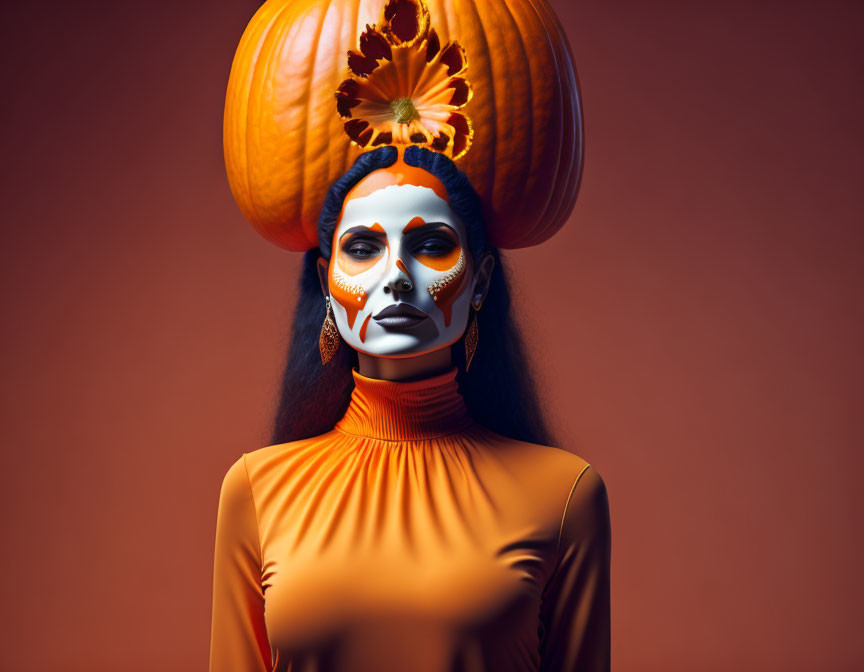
(540, 466), (611, 672)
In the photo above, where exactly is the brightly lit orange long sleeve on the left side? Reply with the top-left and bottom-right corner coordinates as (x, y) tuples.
(210, 455), (272, 672)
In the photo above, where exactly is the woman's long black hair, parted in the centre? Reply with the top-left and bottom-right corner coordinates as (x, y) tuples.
(271, 146), (552, 445)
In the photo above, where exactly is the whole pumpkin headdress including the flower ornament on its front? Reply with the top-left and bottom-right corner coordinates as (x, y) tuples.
(223, 0), (583, 251)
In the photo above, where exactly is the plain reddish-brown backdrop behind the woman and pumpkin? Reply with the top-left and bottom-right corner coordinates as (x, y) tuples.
(0, 0), (864, 672)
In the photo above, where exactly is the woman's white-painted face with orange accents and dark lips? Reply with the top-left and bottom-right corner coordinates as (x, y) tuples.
(329, 184), (473, 357)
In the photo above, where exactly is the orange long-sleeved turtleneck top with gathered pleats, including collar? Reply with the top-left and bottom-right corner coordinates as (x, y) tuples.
(210, 368), (610, 672)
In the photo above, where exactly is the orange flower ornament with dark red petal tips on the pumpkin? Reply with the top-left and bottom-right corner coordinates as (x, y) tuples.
(336, 0), (474, 159)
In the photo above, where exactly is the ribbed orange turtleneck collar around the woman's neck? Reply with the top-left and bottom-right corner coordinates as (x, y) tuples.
(336, 367), (473, 441)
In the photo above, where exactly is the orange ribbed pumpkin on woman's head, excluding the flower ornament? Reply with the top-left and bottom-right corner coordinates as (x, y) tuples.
(223, 0), (583, 251)
